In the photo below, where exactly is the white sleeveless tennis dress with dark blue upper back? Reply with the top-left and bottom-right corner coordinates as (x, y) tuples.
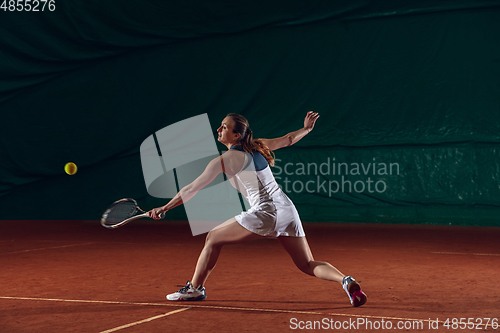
(231, 146), (305, 237)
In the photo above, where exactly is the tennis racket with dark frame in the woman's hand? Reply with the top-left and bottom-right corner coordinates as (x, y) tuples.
(101, 198), (165, 229)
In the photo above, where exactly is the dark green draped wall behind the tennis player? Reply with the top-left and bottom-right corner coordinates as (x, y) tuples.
(0, 0), (500, 225)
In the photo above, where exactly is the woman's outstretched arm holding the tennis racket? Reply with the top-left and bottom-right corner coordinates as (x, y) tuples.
(148, 157), (222, 220)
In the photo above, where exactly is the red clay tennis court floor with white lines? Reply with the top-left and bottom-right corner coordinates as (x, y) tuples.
(0, 220), (500, 333)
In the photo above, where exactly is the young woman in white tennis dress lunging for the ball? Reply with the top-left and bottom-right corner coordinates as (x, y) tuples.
(148, 111), (366, 306)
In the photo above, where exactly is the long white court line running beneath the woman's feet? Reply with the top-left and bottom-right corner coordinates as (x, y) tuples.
(0, 296), (468, 326)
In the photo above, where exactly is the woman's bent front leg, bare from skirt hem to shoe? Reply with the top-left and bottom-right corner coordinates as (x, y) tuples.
(191, 217), (262, 288)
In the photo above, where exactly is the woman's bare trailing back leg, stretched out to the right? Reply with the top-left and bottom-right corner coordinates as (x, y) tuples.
(278, 236), (345, 284)
